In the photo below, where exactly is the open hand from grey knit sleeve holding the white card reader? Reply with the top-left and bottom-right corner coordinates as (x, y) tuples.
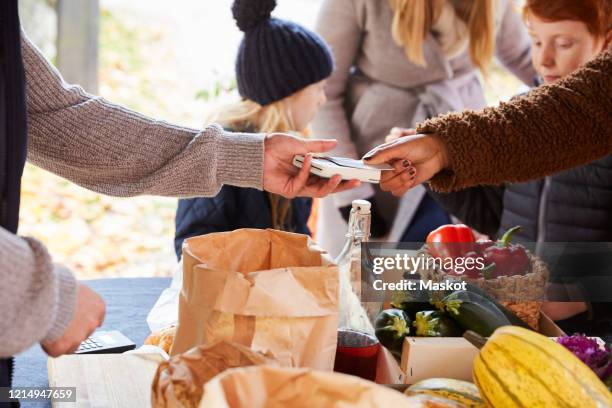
(263, 133), (361, 198)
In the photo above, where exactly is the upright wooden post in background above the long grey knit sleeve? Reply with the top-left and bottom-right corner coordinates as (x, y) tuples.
(57, 0), (100, 94)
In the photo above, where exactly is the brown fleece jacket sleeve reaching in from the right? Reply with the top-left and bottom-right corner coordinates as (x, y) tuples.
(417, 49), (612, 192)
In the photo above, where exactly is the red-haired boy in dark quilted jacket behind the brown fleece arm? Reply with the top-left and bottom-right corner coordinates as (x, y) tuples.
(428, 0), (612, 340)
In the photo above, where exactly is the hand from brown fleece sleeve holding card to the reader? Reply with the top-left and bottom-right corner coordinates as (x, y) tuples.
(363, 134), (448, 197)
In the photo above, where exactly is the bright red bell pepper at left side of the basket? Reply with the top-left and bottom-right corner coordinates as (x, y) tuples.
(427, 224), (476, 259)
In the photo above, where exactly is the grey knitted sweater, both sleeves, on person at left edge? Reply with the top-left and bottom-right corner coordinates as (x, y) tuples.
(0, 35), (264, 356)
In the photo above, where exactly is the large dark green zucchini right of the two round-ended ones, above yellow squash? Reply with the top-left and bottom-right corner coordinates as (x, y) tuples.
(437, 290), (510, 337)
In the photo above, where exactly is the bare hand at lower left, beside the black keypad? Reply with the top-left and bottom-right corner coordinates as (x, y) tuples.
(41, 283), (106, 357)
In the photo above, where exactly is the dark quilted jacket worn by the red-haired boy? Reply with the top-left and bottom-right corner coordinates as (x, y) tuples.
(432, 152), (612, 339)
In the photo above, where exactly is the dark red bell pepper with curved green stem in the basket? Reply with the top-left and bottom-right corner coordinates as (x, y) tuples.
(482, 227), (529, 278)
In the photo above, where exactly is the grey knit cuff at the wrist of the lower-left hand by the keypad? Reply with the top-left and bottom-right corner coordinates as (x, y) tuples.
(41, 265), (77, 342)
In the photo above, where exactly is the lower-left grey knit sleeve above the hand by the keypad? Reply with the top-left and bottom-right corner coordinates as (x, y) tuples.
(0, 228), (76, 357)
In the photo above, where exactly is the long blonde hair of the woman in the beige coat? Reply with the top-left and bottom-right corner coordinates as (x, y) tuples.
(390, 0), (495, 73)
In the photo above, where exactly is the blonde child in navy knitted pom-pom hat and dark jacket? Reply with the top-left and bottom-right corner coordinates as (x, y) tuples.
(174, 0), (333, 258)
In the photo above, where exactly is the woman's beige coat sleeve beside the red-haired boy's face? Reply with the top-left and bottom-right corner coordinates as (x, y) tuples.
(495, 1), (536, 86)
